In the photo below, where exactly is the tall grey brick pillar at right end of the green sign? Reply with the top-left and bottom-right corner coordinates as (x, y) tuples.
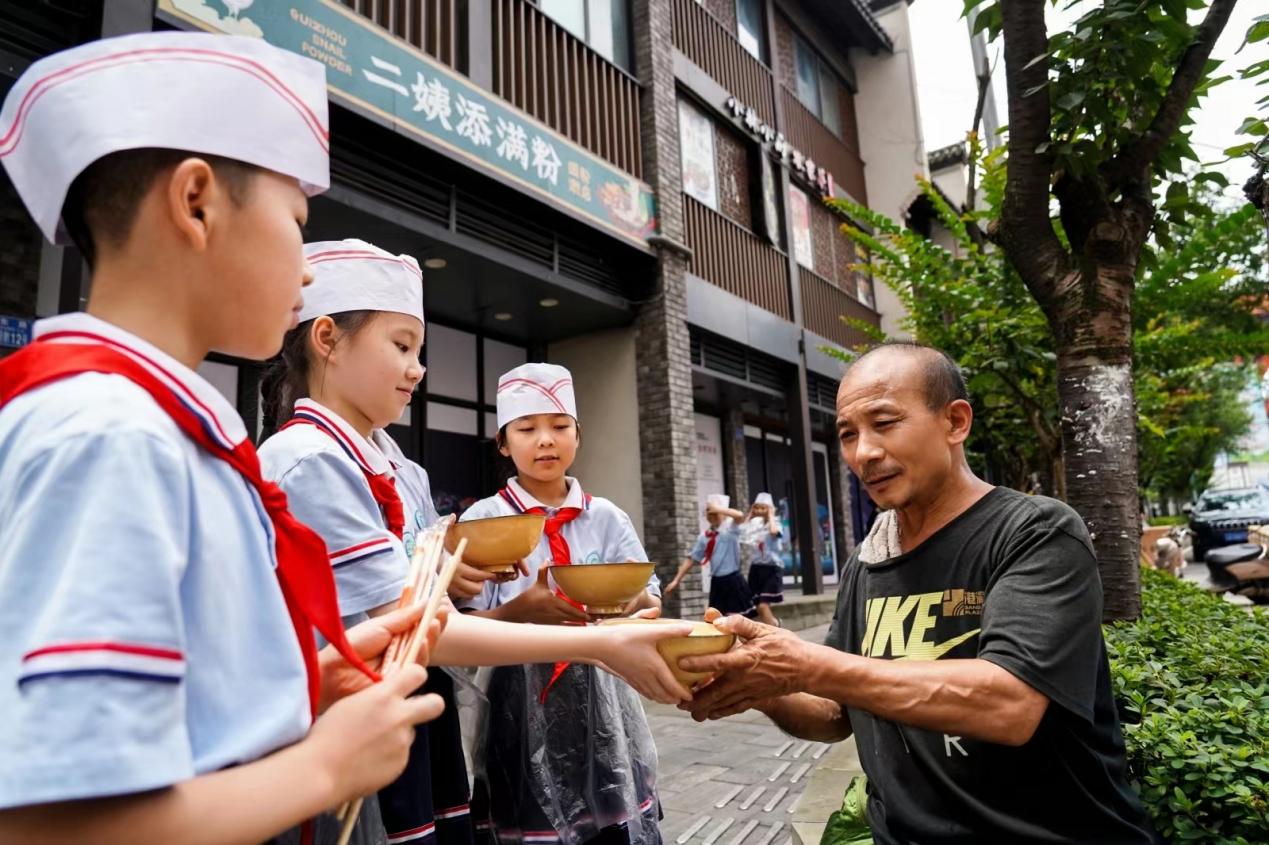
(631, 0), (706, 618)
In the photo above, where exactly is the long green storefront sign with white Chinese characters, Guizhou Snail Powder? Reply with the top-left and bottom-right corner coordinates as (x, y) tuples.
(159, 0), (656, 246)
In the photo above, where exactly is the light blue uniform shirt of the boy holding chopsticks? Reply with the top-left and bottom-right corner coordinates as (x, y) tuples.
(0, 313), (311, 808)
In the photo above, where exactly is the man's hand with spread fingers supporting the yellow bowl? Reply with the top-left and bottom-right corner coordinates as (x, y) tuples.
(679, 608), (806, 722)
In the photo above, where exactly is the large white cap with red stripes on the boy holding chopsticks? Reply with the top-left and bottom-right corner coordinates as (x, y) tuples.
(0, 32), (330, 244)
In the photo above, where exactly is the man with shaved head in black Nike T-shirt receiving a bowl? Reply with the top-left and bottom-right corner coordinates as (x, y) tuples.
(683, 344), (1156, 845)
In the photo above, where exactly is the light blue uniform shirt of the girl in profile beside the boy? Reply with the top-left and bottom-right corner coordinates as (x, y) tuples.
(260, 398), (409, 616)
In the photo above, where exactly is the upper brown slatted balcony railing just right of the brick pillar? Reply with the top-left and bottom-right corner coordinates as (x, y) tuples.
(674, 0), (775, 126)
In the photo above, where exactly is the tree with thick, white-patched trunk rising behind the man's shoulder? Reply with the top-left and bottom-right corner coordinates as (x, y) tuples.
(964, 0), (1269, 619)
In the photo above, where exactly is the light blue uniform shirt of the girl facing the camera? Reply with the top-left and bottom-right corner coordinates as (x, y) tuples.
(459, 477), (661, 610)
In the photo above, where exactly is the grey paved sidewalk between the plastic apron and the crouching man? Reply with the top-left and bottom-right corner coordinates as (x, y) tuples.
(646, 626), (858, 845)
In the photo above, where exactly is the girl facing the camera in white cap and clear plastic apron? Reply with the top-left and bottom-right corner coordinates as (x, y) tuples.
(461, 364), (661, 845)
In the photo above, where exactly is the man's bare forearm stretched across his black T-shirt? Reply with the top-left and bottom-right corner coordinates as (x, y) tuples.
(805, 646), (1048, 745)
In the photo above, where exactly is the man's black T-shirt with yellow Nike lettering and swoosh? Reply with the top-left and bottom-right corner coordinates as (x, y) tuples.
(826, 487), (1156, 845)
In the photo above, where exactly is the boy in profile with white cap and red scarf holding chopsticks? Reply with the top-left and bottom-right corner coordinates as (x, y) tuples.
(0, 33), (442, 842)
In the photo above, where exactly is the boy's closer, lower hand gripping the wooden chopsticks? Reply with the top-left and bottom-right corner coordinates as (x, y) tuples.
(306, 666), (445, 801)
